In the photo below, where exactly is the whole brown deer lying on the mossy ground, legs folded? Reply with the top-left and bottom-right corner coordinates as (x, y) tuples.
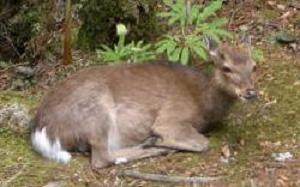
(31, 38), (256, 169)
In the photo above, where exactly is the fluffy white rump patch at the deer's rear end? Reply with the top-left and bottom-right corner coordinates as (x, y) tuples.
(31, 127), (72, 164)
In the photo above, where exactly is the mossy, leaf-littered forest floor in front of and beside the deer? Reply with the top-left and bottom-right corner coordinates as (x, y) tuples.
(0, 2), (300, 187)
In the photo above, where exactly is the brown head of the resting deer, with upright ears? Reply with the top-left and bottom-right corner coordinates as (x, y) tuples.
(209, 38), (257, 100)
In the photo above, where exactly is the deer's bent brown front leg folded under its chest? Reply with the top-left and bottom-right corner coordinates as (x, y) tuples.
(153, 123), (208, 152)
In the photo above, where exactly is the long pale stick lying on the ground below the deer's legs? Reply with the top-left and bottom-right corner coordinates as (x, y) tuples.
(118, 170), (225, 184)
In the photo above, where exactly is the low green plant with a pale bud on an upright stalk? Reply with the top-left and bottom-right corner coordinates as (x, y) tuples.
(96, 24), (155, 63)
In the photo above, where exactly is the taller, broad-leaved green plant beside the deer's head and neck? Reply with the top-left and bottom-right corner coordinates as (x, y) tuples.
(156, 0), (231, 64)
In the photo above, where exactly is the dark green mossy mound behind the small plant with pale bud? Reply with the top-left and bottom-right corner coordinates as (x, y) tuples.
(77, 0), (162, 50)
